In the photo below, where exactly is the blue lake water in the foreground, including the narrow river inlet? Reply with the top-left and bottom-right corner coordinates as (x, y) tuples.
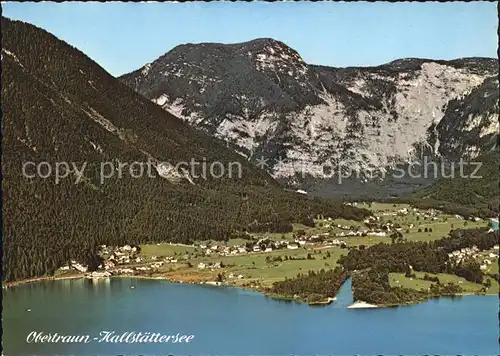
(3, 278), (500, 356)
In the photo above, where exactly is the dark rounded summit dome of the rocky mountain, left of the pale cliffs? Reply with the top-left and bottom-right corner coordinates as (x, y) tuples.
(122, 38), (321, 121)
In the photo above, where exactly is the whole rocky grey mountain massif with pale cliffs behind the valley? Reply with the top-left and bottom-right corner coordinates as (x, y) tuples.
(120, 39), (498, 195)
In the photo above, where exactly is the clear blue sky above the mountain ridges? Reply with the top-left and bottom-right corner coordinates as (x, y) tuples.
(2, 2), (498, 75)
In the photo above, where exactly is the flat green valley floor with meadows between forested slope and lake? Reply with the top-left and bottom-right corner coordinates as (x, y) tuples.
(6, 203), (499, 307)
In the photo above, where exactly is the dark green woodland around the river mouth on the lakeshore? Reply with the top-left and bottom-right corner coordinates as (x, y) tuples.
(270, 228), (499, 305)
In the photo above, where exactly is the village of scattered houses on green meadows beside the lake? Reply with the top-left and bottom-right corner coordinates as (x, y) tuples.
(52, 203), (499, 292)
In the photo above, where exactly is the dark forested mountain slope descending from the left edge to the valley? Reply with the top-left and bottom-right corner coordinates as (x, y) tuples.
(1, 18), (368, 281)
